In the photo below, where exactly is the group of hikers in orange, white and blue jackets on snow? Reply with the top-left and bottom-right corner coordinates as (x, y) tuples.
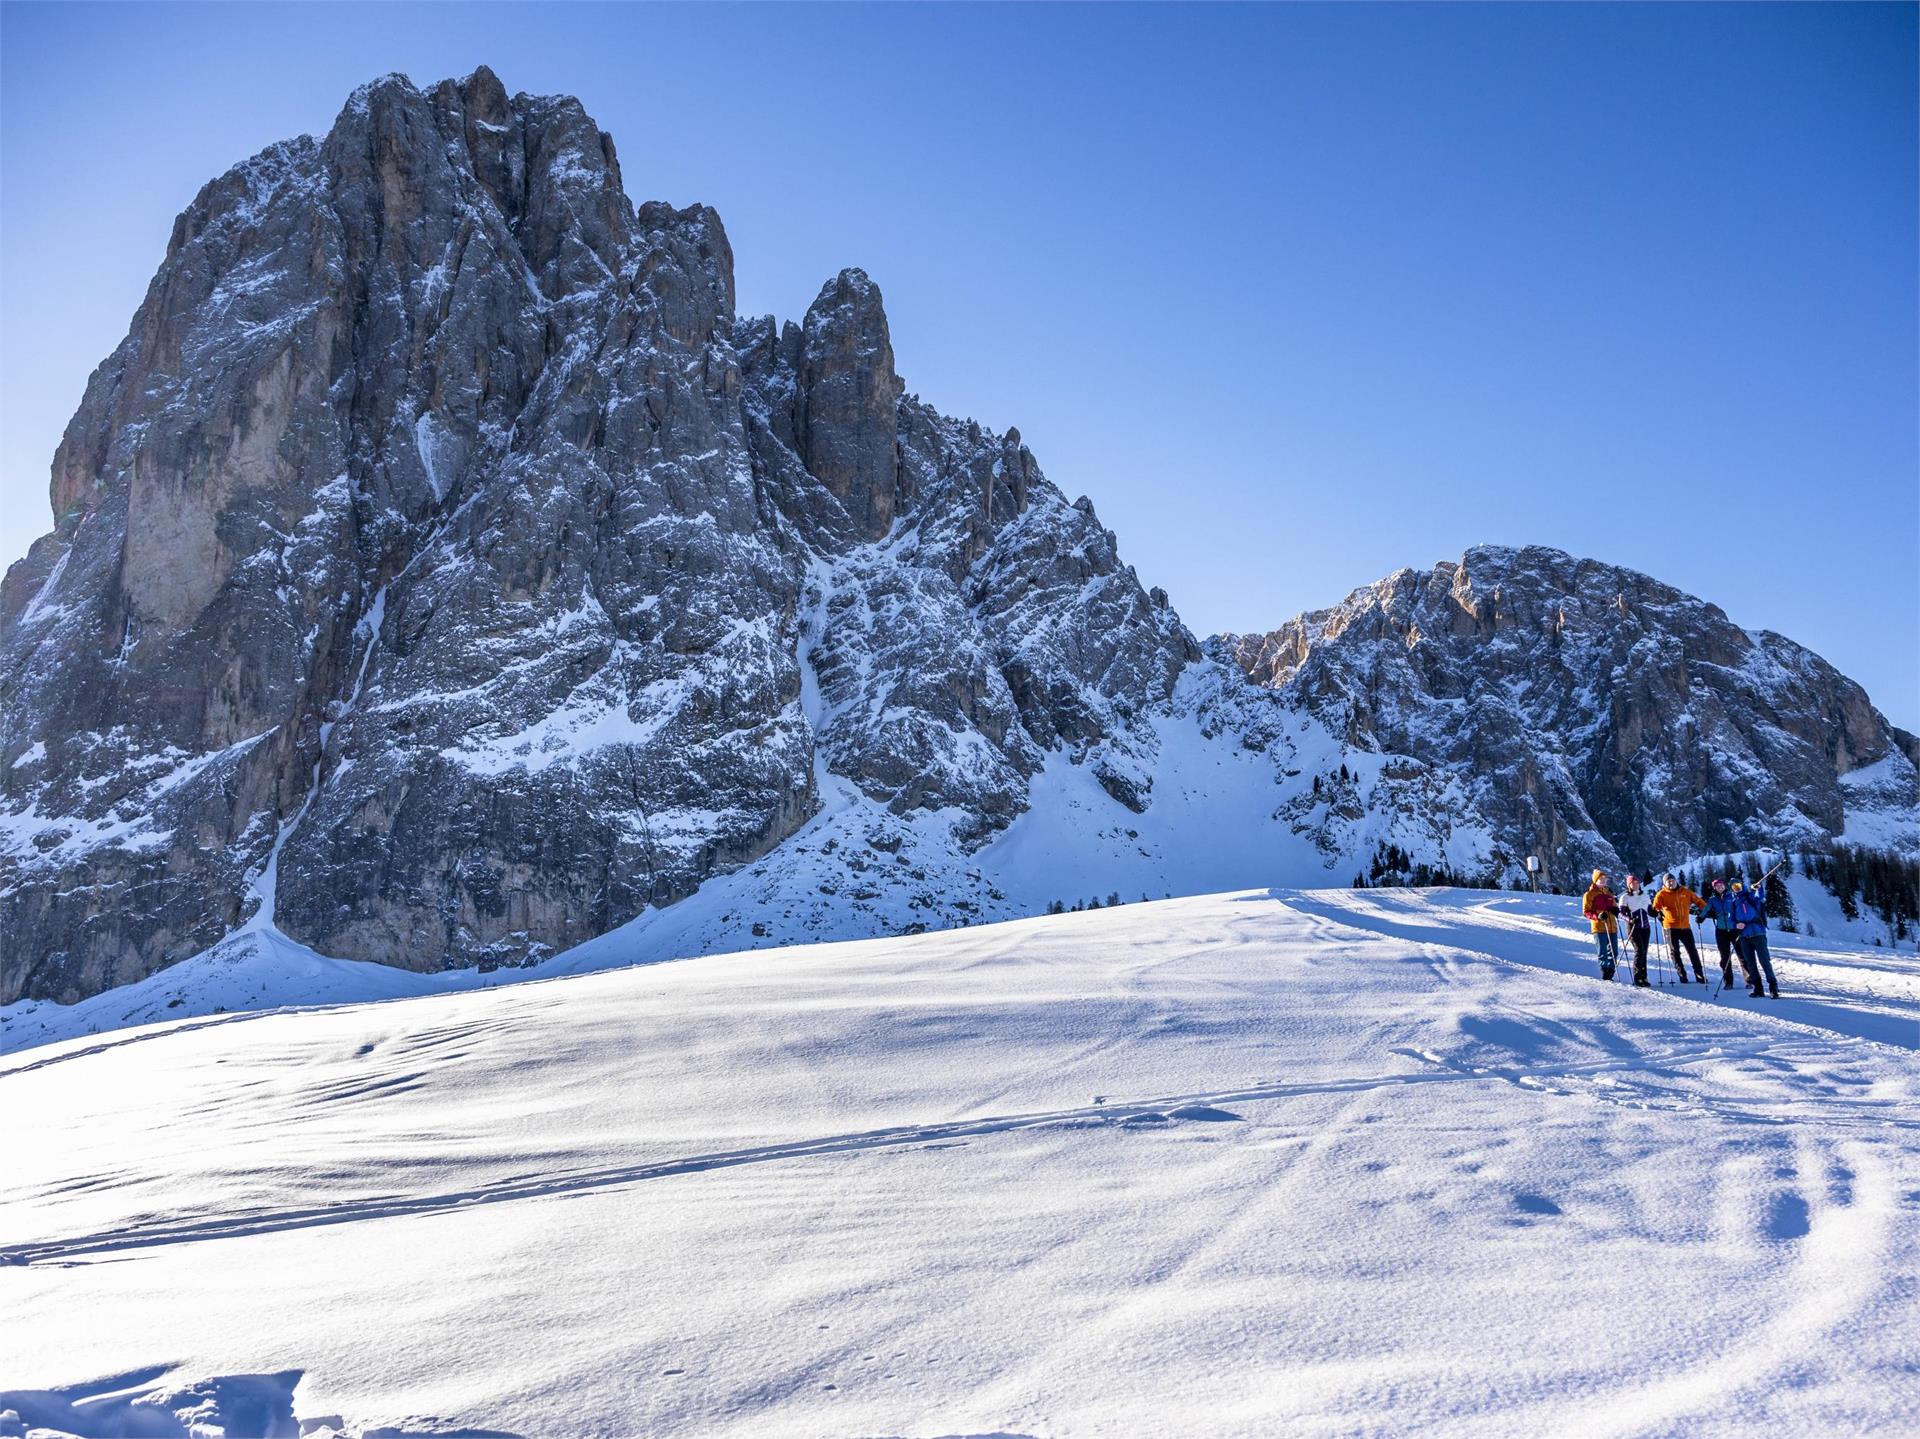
(1582, 870), (1780, 999)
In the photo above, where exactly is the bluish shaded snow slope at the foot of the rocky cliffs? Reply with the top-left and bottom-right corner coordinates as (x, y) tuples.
(0, 665), (1488, 1053)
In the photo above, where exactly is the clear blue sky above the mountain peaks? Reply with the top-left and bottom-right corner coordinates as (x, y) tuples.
(0, 4), (1920, 728)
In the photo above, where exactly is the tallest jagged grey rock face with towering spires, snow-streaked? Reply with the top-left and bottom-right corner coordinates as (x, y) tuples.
(0, 69), (1198, 1001)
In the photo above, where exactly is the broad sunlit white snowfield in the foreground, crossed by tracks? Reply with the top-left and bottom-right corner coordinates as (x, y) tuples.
(0, 890), (1920, 1437)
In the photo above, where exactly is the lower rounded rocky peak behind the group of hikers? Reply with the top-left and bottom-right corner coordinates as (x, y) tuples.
(1219, 546), (1920, 886)
